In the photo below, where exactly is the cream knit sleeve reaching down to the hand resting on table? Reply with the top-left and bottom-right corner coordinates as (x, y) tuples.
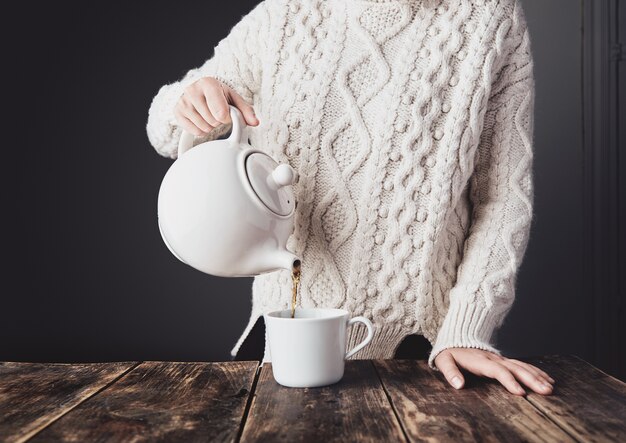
(428, 1), (535, 370)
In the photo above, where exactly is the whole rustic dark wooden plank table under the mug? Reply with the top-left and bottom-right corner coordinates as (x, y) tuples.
(0, 356), (626, 442)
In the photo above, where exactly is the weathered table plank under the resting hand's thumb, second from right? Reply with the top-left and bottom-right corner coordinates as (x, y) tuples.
(374, 360), (573, 442)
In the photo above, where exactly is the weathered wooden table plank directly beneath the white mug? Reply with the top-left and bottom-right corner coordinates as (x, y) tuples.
(241, 360), (405, 442)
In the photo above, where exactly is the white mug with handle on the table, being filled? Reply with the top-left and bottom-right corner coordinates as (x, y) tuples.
(263, 309), (374, 388)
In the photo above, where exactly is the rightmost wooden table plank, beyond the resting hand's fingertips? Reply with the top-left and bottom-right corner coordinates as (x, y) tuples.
(527, 355), (626, 442)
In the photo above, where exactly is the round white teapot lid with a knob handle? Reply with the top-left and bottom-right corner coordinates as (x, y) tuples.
(246, 152), (295, 215)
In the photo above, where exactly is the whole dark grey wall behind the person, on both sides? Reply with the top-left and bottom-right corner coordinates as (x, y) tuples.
(0, 0), (591, 368)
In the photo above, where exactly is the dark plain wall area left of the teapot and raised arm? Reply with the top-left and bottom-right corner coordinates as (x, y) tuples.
(0, 1), (255, 361)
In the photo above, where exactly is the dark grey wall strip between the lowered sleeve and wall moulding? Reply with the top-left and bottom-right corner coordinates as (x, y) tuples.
(498, 0), (593, 358)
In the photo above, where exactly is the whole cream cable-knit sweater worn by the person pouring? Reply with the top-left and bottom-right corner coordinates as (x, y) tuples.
(147, 0), (535, 369)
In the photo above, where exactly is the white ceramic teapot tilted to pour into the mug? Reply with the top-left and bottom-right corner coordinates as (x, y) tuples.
(158, 106), (299, 277)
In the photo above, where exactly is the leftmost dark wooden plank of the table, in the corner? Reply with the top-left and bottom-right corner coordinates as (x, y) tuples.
(0, 362), (136, 441)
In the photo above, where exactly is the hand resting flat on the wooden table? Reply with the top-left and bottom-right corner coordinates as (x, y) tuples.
(435, 348), (554, 395)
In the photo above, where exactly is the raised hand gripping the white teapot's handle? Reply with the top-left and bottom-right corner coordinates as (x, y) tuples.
(174, 77), (259, 136)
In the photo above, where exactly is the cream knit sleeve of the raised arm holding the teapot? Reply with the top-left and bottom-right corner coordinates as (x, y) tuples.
(146, 1), (270, 158)
